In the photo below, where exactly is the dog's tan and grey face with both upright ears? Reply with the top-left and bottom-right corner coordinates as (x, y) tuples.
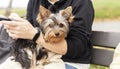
(37, 6), (74, 42)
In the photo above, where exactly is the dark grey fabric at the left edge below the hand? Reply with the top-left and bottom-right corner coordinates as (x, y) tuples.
(0, 24), (15, 64)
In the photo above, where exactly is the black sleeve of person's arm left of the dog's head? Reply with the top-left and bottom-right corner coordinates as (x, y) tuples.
(26, 0), (41, 27)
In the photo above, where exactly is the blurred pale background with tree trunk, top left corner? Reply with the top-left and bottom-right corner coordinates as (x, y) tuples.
(0, 0), (29, 16)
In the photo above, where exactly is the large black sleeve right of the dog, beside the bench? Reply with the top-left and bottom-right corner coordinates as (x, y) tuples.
(63, 0), (94, 62)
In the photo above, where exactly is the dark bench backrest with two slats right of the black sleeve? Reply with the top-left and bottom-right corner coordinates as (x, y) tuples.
(91, 31), (120, 66)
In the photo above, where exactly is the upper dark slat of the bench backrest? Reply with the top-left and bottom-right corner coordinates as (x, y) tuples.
(92, 31), (120, 47)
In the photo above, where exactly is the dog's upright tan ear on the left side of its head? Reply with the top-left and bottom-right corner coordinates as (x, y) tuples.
(37, 5), (51, 23)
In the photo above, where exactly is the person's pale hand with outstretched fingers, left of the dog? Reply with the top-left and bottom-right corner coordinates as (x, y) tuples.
(0, 14), (37, 39)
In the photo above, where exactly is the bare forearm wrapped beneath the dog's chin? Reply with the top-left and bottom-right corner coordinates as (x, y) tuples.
(36, 33), (67, 55)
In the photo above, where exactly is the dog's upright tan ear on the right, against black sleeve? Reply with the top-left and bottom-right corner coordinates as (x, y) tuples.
(61, 6), (74, 23)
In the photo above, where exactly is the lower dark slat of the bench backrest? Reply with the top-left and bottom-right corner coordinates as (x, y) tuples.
(91, 48), (114, 66)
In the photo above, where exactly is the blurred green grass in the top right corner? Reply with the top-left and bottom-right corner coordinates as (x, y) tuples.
(93, 0), (120, 18)
